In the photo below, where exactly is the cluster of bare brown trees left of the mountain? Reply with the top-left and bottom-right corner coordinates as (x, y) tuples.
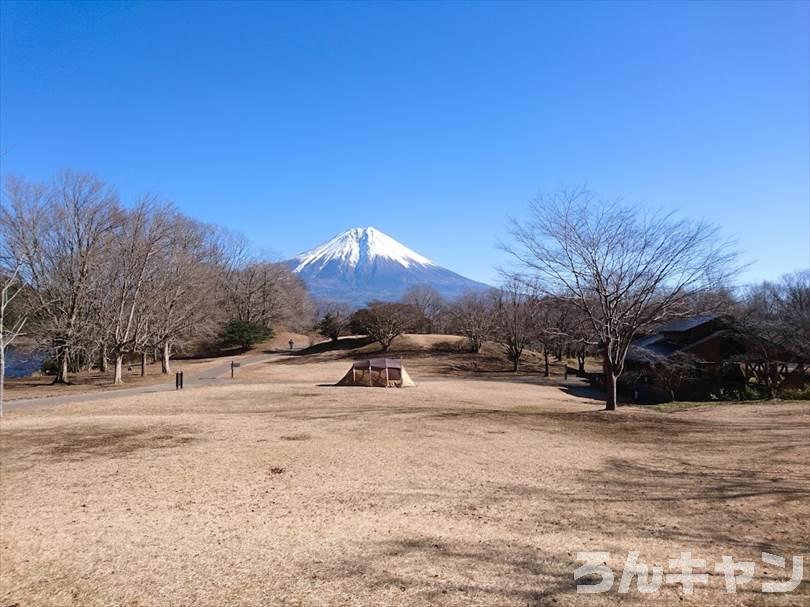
(0, 172), (313, 400)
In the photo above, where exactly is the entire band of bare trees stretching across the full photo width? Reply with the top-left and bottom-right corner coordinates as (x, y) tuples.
(0, 172), (810, 409)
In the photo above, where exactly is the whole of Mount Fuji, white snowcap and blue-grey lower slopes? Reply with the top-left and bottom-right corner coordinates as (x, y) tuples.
(287, 227), (490, 306)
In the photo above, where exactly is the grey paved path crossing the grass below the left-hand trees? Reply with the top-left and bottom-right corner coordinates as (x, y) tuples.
(3, 354), (283, 411)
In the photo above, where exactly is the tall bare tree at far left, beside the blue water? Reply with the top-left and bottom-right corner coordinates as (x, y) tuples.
(0, 172), (121, 383)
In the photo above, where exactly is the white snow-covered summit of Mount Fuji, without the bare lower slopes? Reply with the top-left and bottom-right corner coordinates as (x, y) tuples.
(293, 227), (435, 273)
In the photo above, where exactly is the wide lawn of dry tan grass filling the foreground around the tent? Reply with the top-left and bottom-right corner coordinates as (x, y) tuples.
(0, 338), (810, 607)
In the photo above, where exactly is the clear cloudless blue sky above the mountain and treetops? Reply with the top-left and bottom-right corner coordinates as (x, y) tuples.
(0, 2), (810, 281)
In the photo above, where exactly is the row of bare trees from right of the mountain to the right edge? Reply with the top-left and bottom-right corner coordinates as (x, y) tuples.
(320, 189), (810, 410)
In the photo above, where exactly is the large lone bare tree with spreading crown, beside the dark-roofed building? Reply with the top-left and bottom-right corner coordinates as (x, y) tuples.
(504, 189), (736, 410)
